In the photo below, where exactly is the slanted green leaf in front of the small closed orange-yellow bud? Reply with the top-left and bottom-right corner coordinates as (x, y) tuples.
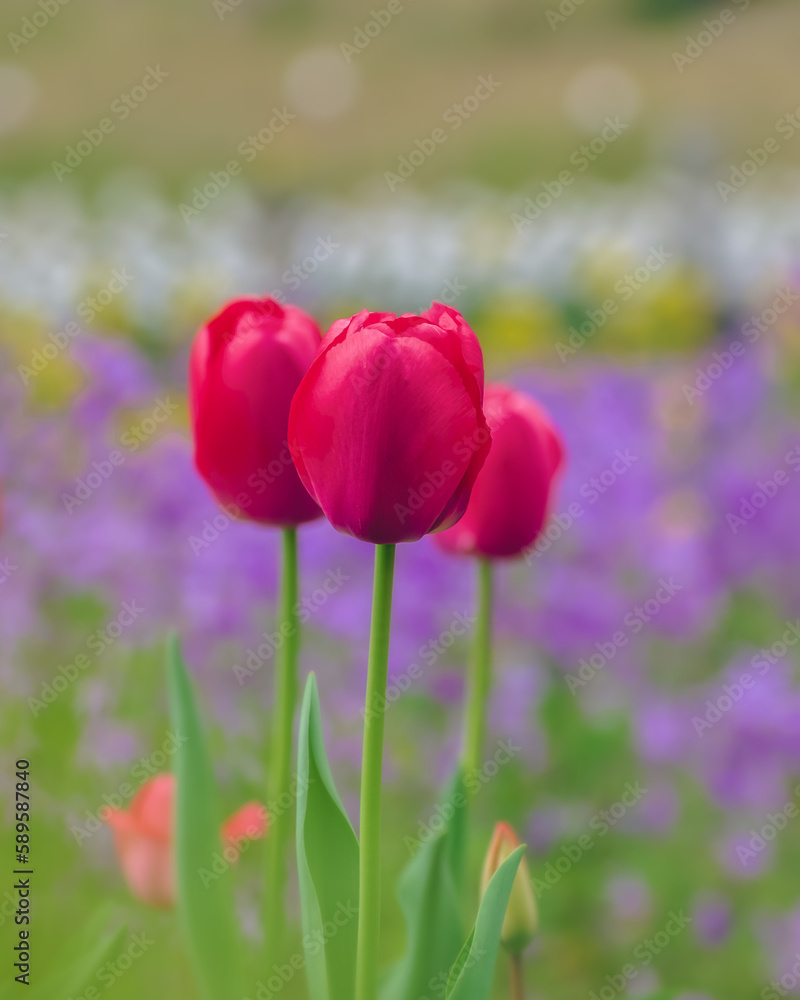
(446, 845), (525, 1000)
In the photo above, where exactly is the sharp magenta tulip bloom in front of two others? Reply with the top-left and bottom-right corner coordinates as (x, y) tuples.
(289, 303), (491, 545)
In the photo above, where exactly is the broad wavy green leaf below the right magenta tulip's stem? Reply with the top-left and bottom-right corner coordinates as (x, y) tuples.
(380, 771), (466, 1000)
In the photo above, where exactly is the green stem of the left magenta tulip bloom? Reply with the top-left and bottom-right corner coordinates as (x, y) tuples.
(263, 528), (300, 975)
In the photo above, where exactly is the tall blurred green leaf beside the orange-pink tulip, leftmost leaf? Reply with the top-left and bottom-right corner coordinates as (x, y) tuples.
(167, 637), (244, 1000)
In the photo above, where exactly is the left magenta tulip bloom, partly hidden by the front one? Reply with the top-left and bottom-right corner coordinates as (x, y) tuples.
(189, 298), (322, 527)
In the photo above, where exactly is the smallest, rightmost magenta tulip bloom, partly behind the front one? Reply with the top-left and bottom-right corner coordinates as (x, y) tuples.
(435, 383), (564, 559)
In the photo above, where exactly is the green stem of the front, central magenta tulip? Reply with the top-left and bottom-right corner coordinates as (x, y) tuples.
(356, 545), (395, 1000)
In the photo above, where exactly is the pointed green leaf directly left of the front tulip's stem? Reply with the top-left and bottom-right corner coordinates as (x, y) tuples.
(297, 674), (359, 1000)
